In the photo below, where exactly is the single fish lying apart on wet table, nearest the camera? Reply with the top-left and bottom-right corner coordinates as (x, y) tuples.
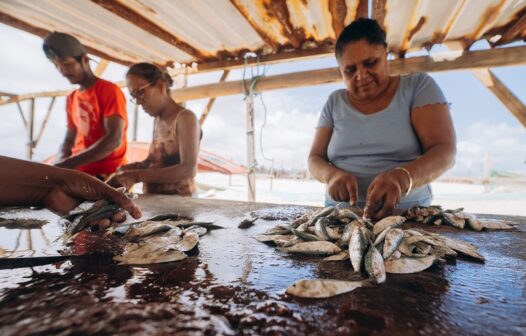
(286, 279), (365, 299)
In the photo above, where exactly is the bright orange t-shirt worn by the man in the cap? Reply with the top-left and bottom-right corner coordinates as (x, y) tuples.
(66, 79), (128, 175)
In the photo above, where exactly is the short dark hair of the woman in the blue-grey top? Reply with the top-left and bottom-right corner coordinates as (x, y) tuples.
(335, 18), (387, 58)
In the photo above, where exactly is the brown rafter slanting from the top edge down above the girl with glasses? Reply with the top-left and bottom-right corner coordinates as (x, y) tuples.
(92, 0), (210, 61)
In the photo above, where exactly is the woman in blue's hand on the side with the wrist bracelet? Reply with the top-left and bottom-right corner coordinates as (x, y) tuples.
(364, 169), (409, 219)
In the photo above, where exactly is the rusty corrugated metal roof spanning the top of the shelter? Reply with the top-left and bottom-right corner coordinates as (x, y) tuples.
(0, 0), (526, 69)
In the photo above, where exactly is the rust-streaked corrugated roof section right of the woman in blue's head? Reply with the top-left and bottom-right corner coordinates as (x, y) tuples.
(383, 0), (526, 55)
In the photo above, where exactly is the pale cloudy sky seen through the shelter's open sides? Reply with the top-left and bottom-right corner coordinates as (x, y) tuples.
(0, 24), (526, 177)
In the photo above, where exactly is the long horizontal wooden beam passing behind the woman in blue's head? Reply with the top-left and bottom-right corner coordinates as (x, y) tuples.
(172, 47), (526, 102)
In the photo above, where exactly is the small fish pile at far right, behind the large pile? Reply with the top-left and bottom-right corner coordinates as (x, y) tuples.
(404, 205), (513, 231)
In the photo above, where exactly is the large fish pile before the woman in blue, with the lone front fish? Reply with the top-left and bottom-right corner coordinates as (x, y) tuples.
(255, 207), (484, 297)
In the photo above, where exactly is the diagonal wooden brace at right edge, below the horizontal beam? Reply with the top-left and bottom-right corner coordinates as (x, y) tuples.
(472, 69), (526, 127)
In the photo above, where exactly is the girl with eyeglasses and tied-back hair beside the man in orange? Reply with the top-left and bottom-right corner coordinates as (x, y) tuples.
(108, 63), (201, 196)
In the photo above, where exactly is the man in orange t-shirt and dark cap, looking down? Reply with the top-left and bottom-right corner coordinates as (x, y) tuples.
(43, 32), (128, 179)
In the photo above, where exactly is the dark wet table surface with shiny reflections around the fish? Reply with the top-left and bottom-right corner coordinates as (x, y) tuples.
(0, 196), (526, 335)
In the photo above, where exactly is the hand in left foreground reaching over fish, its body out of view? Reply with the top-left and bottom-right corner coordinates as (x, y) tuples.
(42, 171), (142, 228)
